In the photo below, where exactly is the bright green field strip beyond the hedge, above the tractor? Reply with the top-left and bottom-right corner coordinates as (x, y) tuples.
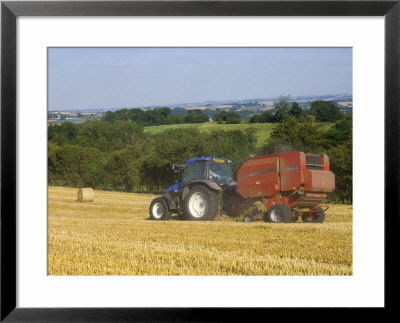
(144, 122), (276, 147)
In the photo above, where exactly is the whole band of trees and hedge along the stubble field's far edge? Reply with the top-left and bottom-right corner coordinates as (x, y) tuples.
(48, 100), (352, 203)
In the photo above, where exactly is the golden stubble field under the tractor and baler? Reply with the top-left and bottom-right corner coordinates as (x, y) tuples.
(48, 187), (352, 275)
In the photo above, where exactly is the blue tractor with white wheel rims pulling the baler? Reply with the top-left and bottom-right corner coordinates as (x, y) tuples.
(149, 157), (236, 221)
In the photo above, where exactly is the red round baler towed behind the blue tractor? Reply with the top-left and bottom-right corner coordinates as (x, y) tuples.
(237, 152), (335, 222)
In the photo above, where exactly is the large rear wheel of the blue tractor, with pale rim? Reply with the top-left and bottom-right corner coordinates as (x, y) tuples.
(185, 185), (220, 221)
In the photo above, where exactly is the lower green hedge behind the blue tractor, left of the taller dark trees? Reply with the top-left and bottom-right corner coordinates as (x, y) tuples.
(48, 120), (257, 192)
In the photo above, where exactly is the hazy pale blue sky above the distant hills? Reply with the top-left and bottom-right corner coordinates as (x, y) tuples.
(48, 48), (353, 111)
